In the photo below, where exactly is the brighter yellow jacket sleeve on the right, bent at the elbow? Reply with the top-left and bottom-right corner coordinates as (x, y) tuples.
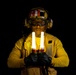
(52, 39), (69, 67)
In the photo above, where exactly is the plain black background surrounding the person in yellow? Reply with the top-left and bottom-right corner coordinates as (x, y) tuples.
(0, 0), (76, 75)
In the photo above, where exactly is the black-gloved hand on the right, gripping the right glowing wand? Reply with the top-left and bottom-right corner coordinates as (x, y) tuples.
(38, 52), (52, 66)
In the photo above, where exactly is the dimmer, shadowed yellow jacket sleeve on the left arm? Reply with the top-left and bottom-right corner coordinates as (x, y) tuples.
(7, 39), (24, 68)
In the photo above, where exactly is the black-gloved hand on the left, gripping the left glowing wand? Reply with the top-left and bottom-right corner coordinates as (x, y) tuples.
(24, 53), (38, 66)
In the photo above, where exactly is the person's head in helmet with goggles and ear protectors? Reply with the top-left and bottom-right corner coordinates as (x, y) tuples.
(25, 7), (53, 36)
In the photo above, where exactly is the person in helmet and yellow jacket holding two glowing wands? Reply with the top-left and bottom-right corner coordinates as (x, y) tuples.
(7, 7), (69, 75)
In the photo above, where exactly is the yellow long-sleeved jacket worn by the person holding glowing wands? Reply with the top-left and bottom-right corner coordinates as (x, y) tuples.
(7, 33), (69, 75)
